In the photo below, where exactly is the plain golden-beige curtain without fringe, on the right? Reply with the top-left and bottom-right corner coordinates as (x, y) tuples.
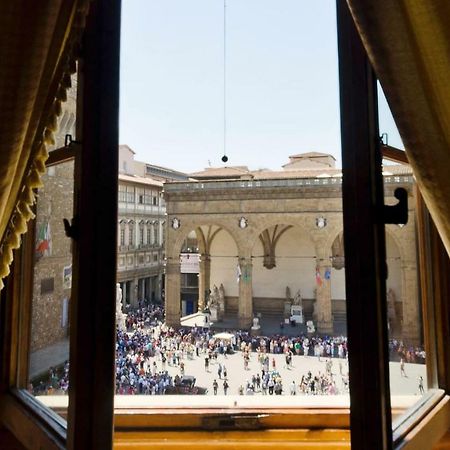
(348, 0), (450, 255)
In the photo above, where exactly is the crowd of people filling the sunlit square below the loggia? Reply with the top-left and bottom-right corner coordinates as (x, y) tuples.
(30, 306), (425, 395)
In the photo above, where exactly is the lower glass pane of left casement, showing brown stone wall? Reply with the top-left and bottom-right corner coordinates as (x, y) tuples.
(28, 161), (74, 416)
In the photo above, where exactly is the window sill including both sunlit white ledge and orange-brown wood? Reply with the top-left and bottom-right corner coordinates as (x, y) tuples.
(10, 391), (450, 450)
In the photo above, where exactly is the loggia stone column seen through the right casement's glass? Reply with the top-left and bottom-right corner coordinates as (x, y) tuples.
(402, 262), (422, 345)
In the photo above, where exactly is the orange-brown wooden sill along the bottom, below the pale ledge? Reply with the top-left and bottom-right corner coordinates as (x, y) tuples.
(0, 392), (450, 450)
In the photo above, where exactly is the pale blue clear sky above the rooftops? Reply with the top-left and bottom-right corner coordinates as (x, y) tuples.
(120, 0), (403, 173)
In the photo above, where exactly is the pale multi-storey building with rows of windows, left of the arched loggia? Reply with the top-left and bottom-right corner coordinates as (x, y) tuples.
(117, 145), (188, 307)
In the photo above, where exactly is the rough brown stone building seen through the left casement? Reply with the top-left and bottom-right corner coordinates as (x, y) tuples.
(30, 77), (77, 356)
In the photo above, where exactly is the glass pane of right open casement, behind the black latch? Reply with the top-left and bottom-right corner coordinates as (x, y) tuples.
(378, 86), (434, 426)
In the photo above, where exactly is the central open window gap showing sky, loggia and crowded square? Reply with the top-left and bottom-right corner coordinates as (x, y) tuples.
(116, 0), (348, 407)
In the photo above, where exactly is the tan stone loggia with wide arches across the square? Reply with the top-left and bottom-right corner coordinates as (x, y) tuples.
(164, 152), (421, 342)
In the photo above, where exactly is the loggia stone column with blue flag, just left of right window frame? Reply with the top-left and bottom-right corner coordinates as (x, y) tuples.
(315, 258), (333, 334)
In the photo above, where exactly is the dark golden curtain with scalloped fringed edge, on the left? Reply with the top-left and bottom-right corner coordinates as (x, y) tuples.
(0, 0), (88, 288)
